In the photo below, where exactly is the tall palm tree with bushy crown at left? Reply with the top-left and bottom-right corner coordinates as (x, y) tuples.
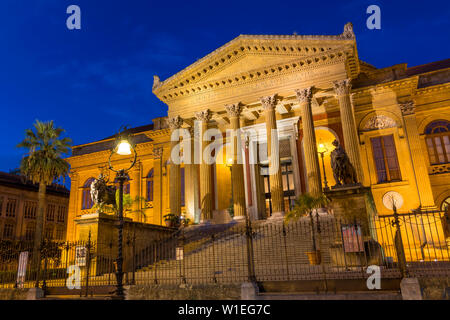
(17, 120), (72, 265)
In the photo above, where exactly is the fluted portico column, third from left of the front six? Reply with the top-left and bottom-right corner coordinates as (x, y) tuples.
(225, 103), (247, 219)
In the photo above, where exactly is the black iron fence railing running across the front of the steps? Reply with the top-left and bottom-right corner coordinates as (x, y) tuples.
(0, 212), (450, 292)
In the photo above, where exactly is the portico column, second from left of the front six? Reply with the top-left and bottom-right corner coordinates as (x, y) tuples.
(195, 110), (213, 223)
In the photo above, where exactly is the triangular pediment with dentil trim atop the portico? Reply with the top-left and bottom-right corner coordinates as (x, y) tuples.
(153, 24), (357, 100)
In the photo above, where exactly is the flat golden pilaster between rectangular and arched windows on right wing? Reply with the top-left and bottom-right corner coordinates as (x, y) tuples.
(400, 101), (436, 209)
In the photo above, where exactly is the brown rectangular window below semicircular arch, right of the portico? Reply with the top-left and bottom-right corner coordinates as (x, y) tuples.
(370, 135), (401, 183)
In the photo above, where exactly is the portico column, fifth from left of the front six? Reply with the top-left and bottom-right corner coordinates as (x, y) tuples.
(295, 87), (322, 195)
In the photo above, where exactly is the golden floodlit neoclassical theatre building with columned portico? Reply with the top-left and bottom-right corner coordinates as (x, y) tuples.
(67, 23), (450, 240)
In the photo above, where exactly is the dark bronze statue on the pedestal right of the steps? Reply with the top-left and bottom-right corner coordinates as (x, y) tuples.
(331, 140), (358, 187)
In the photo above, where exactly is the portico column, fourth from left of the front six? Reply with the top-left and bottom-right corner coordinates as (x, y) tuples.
(260, 95), (285, 217)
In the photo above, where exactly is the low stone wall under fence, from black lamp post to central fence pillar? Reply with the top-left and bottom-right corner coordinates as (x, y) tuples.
(126, 284), (241, 300)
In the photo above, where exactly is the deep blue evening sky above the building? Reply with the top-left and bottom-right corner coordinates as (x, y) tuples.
(0, 0), (450, 175)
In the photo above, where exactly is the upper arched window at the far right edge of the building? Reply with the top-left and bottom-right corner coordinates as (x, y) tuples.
(425, 120), (450, 164)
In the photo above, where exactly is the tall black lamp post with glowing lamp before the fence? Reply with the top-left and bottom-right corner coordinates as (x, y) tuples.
(108, 128), (137, 300)
